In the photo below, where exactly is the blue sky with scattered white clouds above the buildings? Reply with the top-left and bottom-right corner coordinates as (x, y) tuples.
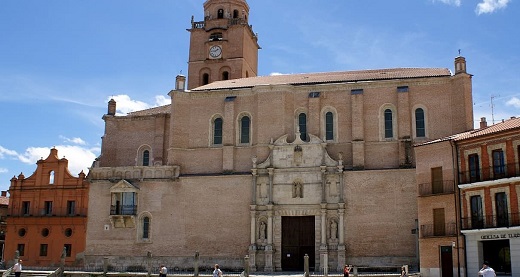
(0, 0), (520, 193)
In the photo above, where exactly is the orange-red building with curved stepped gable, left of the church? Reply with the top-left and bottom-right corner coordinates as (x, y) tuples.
(4, 148), (89, 267)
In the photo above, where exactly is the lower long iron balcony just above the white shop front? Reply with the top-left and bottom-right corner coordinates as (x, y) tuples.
(461, 213), (520, 230)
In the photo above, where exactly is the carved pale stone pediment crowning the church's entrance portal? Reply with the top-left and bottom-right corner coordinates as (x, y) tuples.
(257, 133), (340, 169)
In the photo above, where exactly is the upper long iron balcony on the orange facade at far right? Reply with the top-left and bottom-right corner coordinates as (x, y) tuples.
(459, 164), (520, 185)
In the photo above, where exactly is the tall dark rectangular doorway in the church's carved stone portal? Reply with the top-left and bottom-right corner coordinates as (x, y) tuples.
(282, 216), (315, 271)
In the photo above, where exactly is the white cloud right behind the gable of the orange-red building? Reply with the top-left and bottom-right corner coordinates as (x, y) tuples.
(18, 145), (101, 176)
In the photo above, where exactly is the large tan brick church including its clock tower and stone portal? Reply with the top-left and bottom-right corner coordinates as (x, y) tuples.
(84, 0), (473, 272)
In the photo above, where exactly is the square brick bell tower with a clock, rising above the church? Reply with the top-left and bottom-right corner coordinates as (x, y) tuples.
(188, 0), (260, 89)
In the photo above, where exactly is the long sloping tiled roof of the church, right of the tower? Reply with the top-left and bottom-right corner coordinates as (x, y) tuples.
(192, 68), (451, 91)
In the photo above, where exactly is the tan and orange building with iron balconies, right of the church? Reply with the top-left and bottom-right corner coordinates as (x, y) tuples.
(415, 118), (520, 277)
